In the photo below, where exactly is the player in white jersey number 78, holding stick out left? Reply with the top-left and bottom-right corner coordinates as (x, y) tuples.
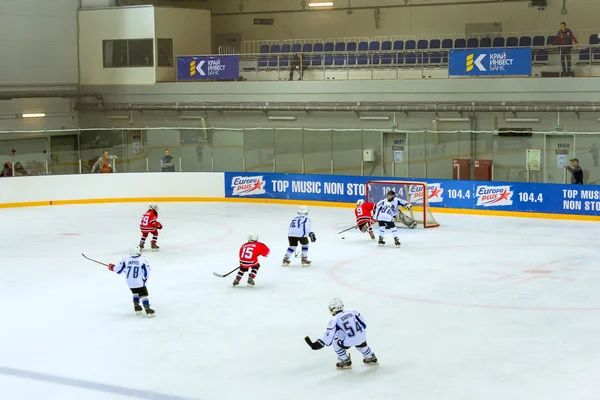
(108, 246), (154, 318)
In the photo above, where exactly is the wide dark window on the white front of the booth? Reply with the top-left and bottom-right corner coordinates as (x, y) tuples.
(102, 39), (154, 68)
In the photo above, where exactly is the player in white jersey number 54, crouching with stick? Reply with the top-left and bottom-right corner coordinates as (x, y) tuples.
(304, 298), (377, 369)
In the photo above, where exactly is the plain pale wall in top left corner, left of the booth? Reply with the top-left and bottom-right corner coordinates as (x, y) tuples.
(0, 0), (79, 86)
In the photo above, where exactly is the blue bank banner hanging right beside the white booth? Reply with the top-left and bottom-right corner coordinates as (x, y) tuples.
(177, 55), (240, 81)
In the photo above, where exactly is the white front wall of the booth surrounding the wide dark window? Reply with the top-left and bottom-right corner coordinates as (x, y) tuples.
(79, 7), (156, 85)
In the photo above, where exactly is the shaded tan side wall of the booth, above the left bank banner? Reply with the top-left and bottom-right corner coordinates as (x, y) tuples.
(154, 7), (212, 82)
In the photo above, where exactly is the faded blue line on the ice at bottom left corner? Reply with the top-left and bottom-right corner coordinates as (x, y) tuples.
(0, 367), (202, 400)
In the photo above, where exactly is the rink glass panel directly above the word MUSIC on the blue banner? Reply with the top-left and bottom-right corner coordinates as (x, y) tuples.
(302, 130), (337, 174)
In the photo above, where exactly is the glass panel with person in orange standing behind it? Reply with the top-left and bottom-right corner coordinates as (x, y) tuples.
(79, 130), (127, 174)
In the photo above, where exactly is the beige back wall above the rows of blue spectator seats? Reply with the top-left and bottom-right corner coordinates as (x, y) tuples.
(213, 0), (600, 42)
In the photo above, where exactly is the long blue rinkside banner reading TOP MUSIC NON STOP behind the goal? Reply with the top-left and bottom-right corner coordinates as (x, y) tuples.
(225, 172), (600, 216)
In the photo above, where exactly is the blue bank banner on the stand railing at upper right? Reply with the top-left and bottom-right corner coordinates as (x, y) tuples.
(448, 47), (531, 76)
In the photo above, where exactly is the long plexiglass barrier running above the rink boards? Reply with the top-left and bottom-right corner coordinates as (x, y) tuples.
(0, 127), (600, 184)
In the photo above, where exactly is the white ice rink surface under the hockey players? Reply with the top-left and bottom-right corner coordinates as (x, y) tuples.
(0, 203), (600, 400)
